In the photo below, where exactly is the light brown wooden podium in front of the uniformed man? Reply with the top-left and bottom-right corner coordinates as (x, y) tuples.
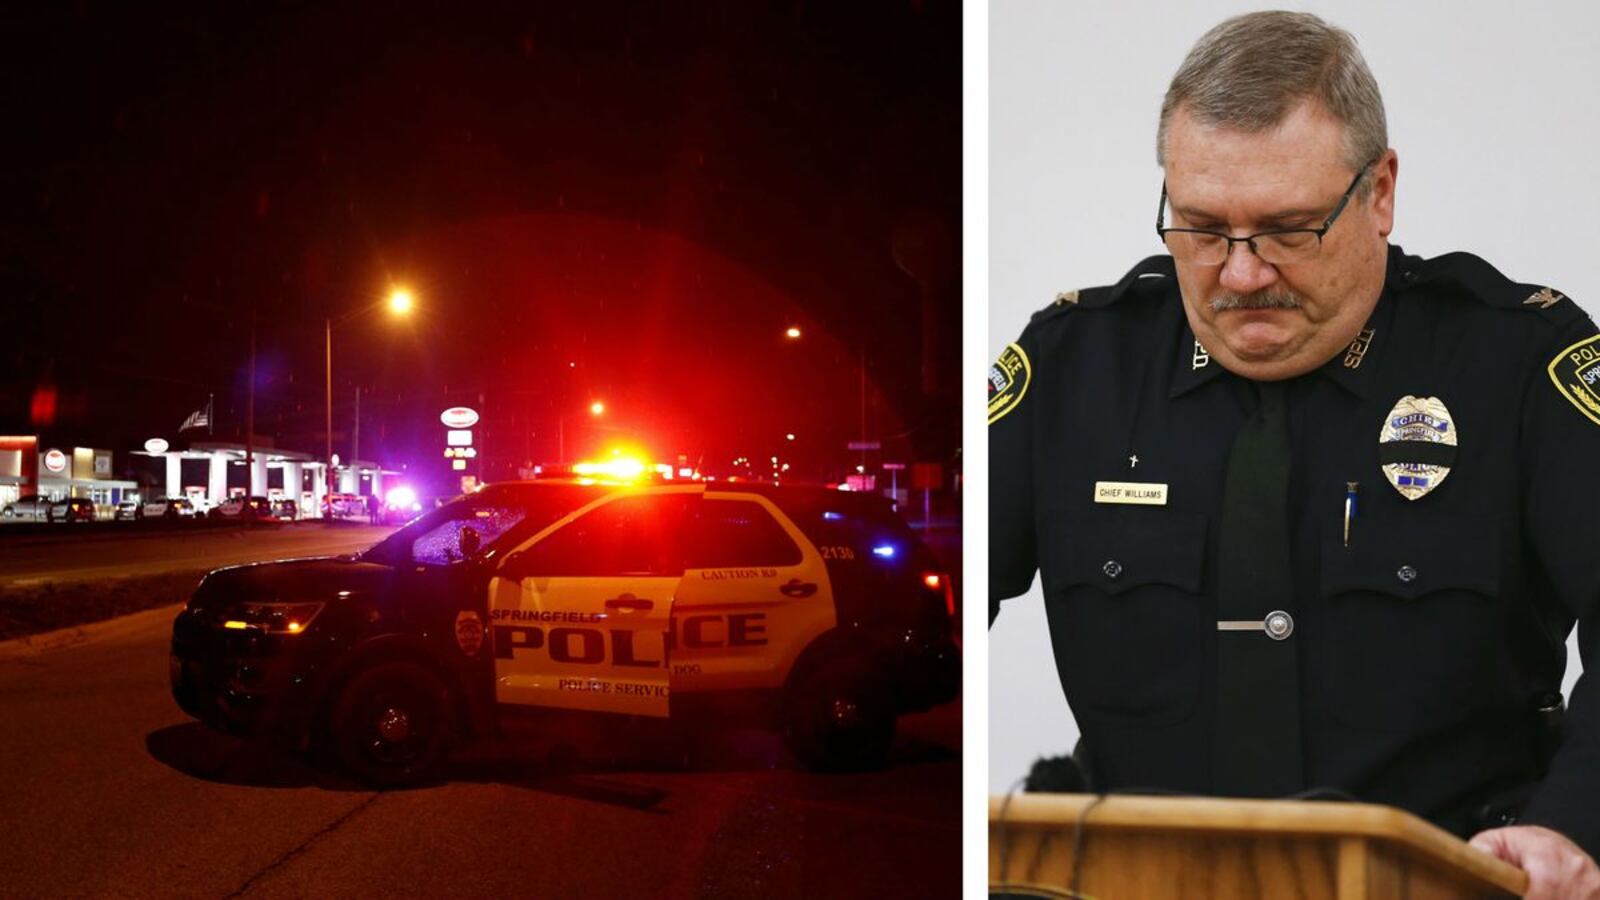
(989, 794), (1528, 900)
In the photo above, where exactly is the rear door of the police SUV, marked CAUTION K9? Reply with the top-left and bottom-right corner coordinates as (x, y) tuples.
(672, 490), (837, 690)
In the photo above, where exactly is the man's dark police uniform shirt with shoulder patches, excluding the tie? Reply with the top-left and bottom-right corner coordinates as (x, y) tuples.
(989, 241), (1600, 854)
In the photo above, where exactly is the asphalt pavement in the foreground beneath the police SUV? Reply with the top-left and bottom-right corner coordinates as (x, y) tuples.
(0, 607), (962, 898)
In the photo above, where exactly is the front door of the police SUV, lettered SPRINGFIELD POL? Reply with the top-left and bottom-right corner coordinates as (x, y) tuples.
(490, 487), (699, 716)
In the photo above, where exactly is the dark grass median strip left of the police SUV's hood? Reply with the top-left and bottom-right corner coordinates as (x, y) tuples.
(0, 569), (210, 641)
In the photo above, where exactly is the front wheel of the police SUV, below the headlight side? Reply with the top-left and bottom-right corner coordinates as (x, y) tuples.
(328, 663), (453, 788)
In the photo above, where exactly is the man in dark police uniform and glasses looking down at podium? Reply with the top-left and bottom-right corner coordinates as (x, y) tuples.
(989, 13), (1600, 897)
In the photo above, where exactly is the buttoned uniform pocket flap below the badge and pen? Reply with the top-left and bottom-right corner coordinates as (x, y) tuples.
(1322, 519), (1501, 599)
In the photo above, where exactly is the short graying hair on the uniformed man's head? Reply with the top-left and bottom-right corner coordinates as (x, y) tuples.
(1155, 11), (1389, 178)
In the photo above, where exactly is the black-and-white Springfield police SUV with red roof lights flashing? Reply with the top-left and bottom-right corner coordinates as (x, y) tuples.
(170, 482), (960, 786)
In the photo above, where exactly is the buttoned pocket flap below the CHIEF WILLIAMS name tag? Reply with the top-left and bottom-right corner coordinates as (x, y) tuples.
(1042, 508), (1206, 594)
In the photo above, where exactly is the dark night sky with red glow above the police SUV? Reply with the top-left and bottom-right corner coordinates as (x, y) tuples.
(0, 2), (960, 490)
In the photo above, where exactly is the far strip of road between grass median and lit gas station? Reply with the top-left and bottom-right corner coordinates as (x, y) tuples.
(0, 522), (394, 588)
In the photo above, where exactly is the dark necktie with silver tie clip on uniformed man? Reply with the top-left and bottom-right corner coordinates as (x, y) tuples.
(1213, 383), (1304, 798)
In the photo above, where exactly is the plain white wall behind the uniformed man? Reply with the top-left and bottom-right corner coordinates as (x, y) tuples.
(987, 0), (1600, 791)
